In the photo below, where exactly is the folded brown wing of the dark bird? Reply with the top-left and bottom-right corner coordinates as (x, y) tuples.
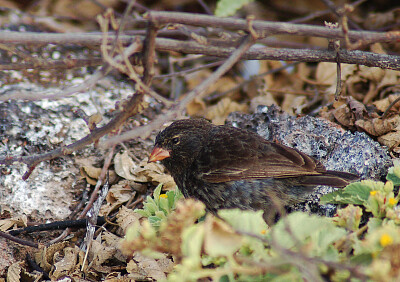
(197, 126), (325, 183)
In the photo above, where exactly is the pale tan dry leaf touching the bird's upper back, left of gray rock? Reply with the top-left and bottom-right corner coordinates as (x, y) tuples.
(205, 98), (247, 125)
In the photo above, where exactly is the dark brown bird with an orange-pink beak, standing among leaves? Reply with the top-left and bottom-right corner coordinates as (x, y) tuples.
(149, 119), (358, 224)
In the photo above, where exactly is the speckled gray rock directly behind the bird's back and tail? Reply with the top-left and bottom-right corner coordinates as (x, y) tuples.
(227, 105), (392, 215)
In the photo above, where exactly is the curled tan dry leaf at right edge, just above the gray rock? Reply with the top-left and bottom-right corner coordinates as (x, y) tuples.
(355, 116), (400, 136)
